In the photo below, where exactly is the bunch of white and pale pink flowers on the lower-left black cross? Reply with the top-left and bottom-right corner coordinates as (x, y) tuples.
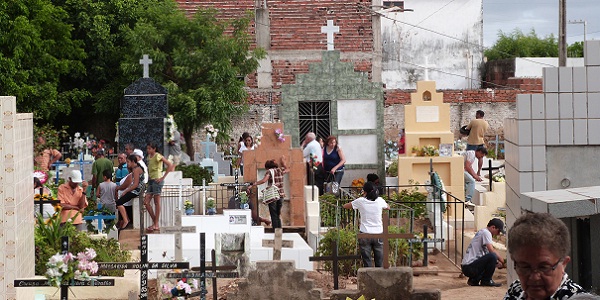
(45, 248), (98, 287)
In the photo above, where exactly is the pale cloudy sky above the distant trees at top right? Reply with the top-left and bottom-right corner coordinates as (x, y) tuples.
(483, 0), (600, 47)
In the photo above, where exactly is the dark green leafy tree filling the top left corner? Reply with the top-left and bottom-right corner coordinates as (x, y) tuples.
(0, 0), (88, 121)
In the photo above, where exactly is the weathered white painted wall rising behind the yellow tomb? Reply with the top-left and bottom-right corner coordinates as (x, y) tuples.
(381, 0), (483, 89)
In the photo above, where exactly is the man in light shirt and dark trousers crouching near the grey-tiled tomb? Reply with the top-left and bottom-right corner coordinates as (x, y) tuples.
(461, 218), (505, 286)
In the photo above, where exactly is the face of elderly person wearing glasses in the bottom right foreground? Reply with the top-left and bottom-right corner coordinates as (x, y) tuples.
(512, 246), (571, 300)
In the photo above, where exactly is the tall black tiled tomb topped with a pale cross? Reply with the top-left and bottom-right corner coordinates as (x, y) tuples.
(119, 55), (169, 155)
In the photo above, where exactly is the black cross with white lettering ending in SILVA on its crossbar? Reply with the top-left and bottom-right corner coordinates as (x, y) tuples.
(98, 234), (190, 300)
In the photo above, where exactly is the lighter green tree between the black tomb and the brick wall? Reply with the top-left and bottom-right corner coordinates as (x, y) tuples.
(122, 1), (265, 156)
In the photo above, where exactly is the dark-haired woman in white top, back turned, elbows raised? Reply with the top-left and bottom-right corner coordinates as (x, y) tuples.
(344, 181), (390, 267)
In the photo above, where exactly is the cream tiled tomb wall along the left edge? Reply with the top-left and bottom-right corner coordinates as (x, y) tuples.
(0, 96), (35, 299)
